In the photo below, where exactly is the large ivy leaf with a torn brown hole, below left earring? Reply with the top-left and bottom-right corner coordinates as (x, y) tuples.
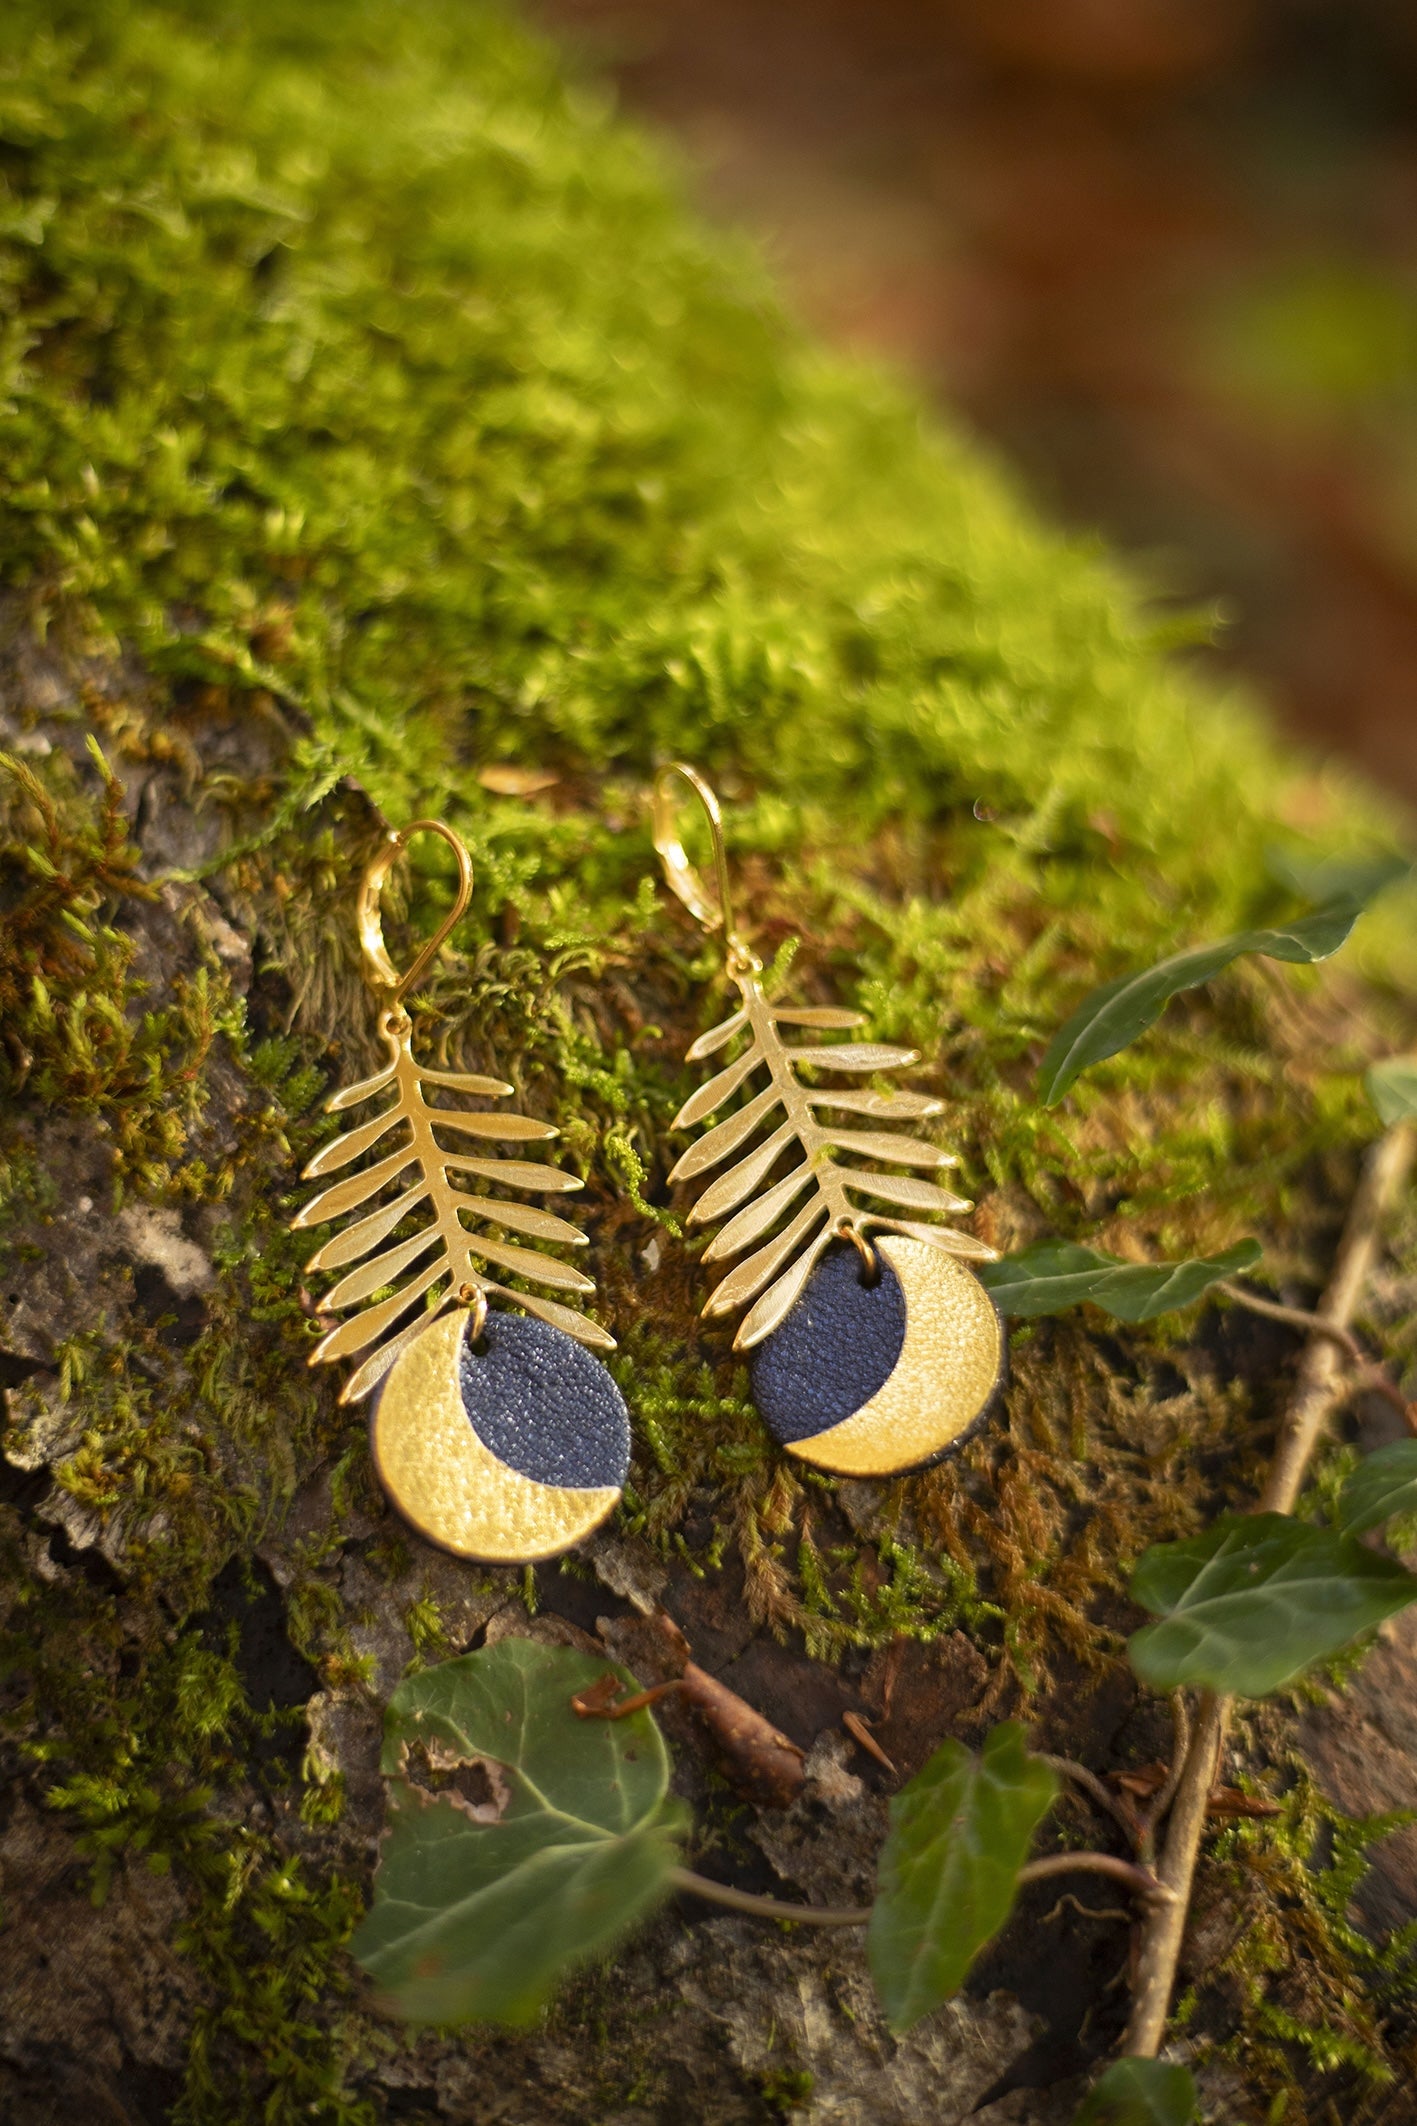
(351, 1639), (678, 2024)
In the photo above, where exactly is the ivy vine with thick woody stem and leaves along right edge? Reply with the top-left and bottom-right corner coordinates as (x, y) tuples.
(964, 871), (1417, 2083)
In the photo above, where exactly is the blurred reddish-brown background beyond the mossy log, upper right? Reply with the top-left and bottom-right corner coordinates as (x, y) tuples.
(533, 0), (1417, 799)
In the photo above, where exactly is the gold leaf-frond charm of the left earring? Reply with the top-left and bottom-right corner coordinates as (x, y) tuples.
(293, 1012), (614, 1403)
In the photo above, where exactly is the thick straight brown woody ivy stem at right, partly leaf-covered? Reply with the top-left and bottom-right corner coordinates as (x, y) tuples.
(1122, 1123), (1413, 2060)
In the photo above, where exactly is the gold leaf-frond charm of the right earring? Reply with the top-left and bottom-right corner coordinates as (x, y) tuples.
(669, 965), (994, 1350)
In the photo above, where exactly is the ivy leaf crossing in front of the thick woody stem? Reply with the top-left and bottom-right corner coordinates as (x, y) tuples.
(1128, 1514), (1417, 1699)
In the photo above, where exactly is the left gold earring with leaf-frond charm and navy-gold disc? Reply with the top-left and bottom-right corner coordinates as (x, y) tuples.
(291, 819), (629, 1563)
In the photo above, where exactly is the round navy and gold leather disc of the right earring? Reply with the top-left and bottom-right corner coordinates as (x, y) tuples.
(752, 1235), (1003, 1475)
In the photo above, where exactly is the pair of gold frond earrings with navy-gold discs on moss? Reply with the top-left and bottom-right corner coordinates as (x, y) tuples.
(293, 761), (1003, 1563)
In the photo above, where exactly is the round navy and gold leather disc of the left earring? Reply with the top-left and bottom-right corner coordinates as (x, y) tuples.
(370, 1310), (629, 1565)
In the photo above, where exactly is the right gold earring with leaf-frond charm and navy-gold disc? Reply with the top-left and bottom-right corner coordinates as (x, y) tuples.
(652, 761), (1003, 1475)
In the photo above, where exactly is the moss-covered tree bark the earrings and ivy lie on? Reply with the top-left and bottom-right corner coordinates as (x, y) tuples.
(0, 0), (1417, 2126)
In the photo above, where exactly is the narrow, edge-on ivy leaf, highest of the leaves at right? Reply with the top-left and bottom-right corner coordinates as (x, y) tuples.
(1039, 857), (1409, 1108)
